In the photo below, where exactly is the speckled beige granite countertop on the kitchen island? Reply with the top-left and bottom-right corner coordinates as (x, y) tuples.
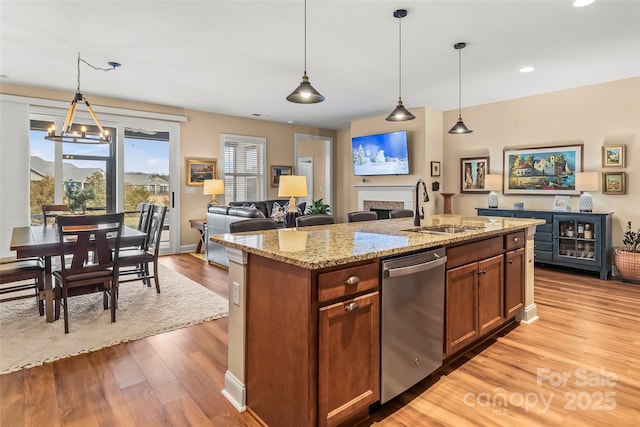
(210, 215), (545, 270)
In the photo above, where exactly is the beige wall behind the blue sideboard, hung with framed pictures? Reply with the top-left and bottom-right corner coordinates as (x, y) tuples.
(443, 78), (640, 246)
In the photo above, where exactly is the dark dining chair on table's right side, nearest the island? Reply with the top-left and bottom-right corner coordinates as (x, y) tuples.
(118, 205), (167, 293)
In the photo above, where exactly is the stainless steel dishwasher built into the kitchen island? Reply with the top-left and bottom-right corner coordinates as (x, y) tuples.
(380, 248), (447, 403)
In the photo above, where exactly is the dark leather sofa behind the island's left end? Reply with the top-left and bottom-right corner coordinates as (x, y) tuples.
(205, 199), (306, 267)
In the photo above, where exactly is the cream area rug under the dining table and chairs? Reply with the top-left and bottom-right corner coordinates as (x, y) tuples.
(0, 265), (229, 375)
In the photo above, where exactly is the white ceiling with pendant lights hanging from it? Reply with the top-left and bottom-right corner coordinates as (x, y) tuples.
(0, 0), (640, 129)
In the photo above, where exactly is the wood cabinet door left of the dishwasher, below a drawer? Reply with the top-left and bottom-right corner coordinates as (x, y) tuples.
(318, 292), (380, 426)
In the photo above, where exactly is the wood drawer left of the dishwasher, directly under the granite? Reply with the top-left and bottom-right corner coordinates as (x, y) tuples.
(318, 262), (379, 303)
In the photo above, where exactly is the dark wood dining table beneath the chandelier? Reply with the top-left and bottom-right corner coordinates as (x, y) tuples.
(10, 225), (147, 323)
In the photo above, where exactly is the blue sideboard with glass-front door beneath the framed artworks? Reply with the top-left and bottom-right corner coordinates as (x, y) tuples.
(476, 208), (613, 280)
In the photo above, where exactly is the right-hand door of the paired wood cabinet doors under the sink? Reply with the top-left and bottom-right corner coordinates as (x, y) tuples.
(478, 255), (504, 335)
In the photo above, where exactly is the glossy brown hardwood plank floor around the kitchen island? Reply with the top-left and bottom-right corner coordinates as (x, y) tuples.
(0, 254), (640, 427)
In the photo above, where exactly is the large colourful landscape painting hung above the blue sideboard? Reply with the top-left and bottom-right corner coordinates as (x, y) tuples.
(502, 144), (583, 196)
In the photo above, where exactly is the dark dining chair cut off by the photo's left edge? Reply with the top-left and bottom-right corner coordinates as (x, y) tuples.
(0, 258), (44, 316)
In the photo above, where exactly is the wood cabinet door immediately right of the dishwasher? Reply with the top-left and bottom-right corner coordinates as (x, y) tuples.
(444, 262), (479, 356)
